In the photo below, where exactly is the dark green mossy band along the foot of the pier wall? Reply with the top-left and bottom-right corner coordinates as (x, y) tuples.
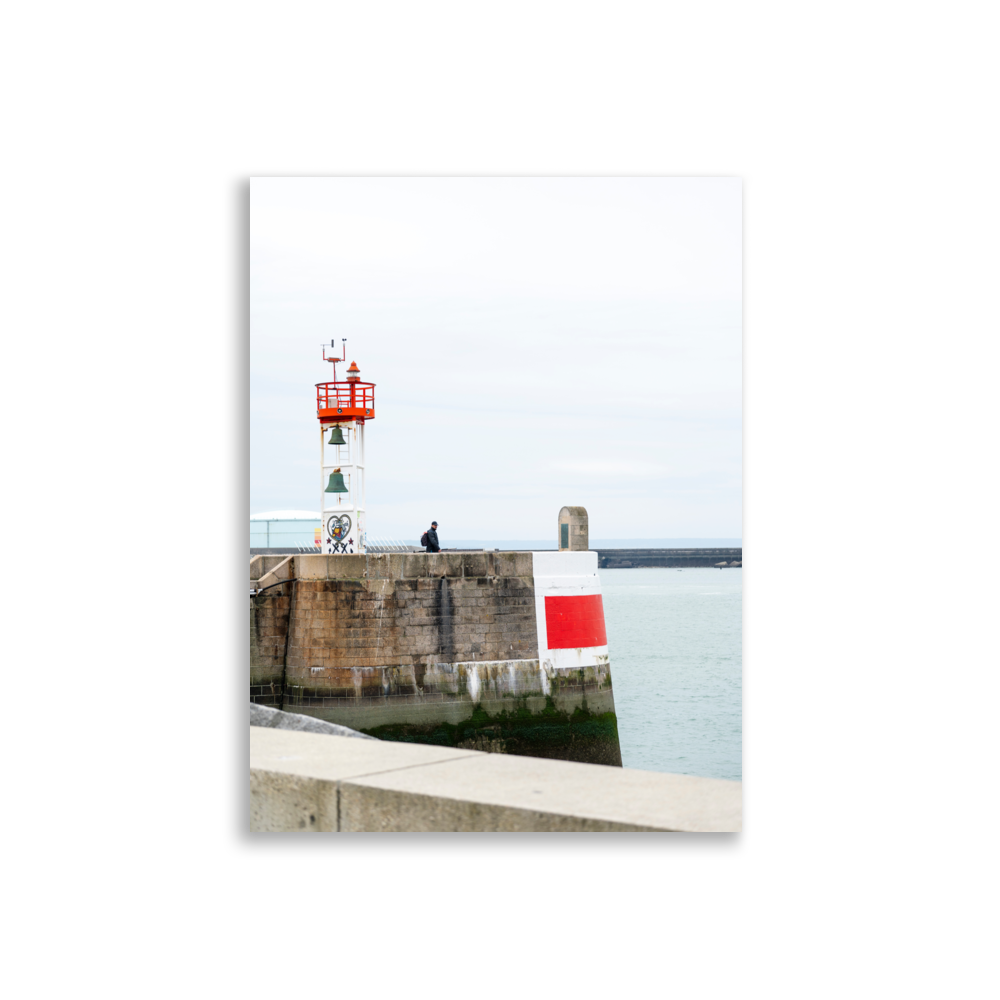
(362, 698), (622, 767)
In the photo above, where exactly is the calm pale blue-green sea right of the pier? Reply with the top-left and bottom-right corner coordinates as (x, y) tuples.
(601, 569), (743, 781)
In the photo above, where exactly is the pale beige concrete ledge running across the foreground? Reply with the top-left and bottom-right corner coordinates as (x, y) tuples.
(250, 728), (743, 833)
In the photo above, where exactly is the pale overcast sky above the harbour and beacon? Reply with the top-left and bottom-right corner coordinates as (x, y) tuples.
(250, 178), (743, 545)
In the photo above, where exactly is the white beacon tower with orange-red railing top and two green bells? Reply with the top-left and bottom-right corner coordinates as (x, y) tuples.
(316, 340), (375, 555)
